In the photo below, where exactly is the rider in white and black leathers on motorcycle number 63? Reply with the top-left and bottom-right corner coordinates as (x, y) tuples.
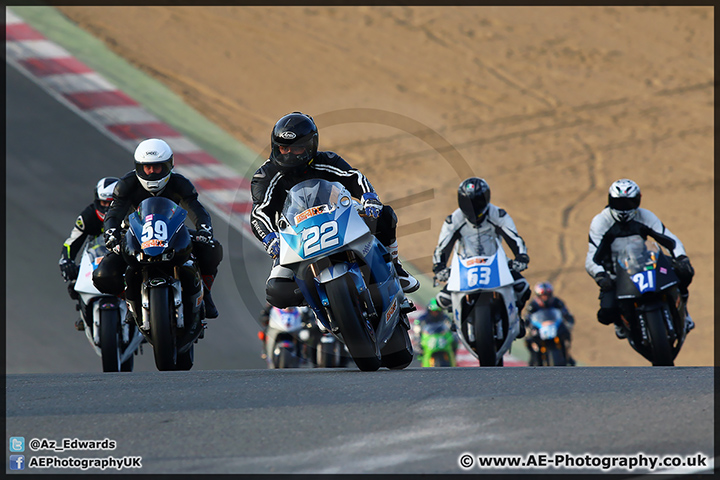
(433, 177), (530, 338)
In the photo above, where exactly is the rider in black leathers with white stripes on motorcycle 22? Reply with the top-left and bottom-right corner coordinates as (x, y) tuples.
(250, 112), (420, 308)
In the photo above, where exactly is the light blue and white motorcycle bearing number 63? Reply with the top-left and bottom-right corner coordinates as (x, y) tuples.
(447, 236), (520, 367)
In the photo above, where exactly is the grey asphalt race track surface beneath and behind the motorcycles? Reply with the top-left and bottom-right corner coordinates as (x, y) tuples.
(6, 61), (714, 474)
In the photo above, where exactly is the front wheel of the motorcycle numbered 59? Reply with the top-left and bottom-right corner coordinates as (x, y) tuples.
(148, 287), (177, 372)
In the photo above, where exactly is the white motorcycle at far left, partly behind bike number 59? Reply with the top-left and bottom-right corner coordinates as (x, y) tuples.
(75, 235), (143, 372)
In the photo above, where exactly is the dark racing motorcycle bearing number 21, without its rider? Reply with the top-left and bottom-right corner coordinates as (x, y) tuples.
(615, 237), (687, 366)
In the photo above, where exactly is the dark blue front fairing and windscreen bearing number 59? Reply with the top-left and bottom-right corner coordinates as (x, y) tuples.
(128, 197), (187, 257)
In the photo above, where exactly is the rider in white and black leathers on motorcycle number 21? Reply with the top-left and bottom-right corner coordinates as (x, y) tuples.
(585, 178), (695, 339)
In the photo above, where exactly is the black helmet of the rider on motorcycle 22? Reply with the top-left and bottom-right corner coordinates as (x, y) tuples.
(270, 112), (318, 170)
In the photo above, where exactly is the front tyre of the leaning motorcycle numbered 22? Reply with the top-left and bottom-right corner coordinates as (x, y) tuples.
(325, 276), (380, 372)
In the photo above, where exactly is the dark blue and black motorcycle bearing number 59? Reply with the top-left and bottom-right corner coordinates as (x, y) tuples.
(125, 197), (204, 371)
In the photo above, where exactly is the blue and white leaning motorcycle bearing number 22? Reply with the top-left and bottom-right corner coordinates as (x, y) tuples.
(278, 179), (414, 371)
